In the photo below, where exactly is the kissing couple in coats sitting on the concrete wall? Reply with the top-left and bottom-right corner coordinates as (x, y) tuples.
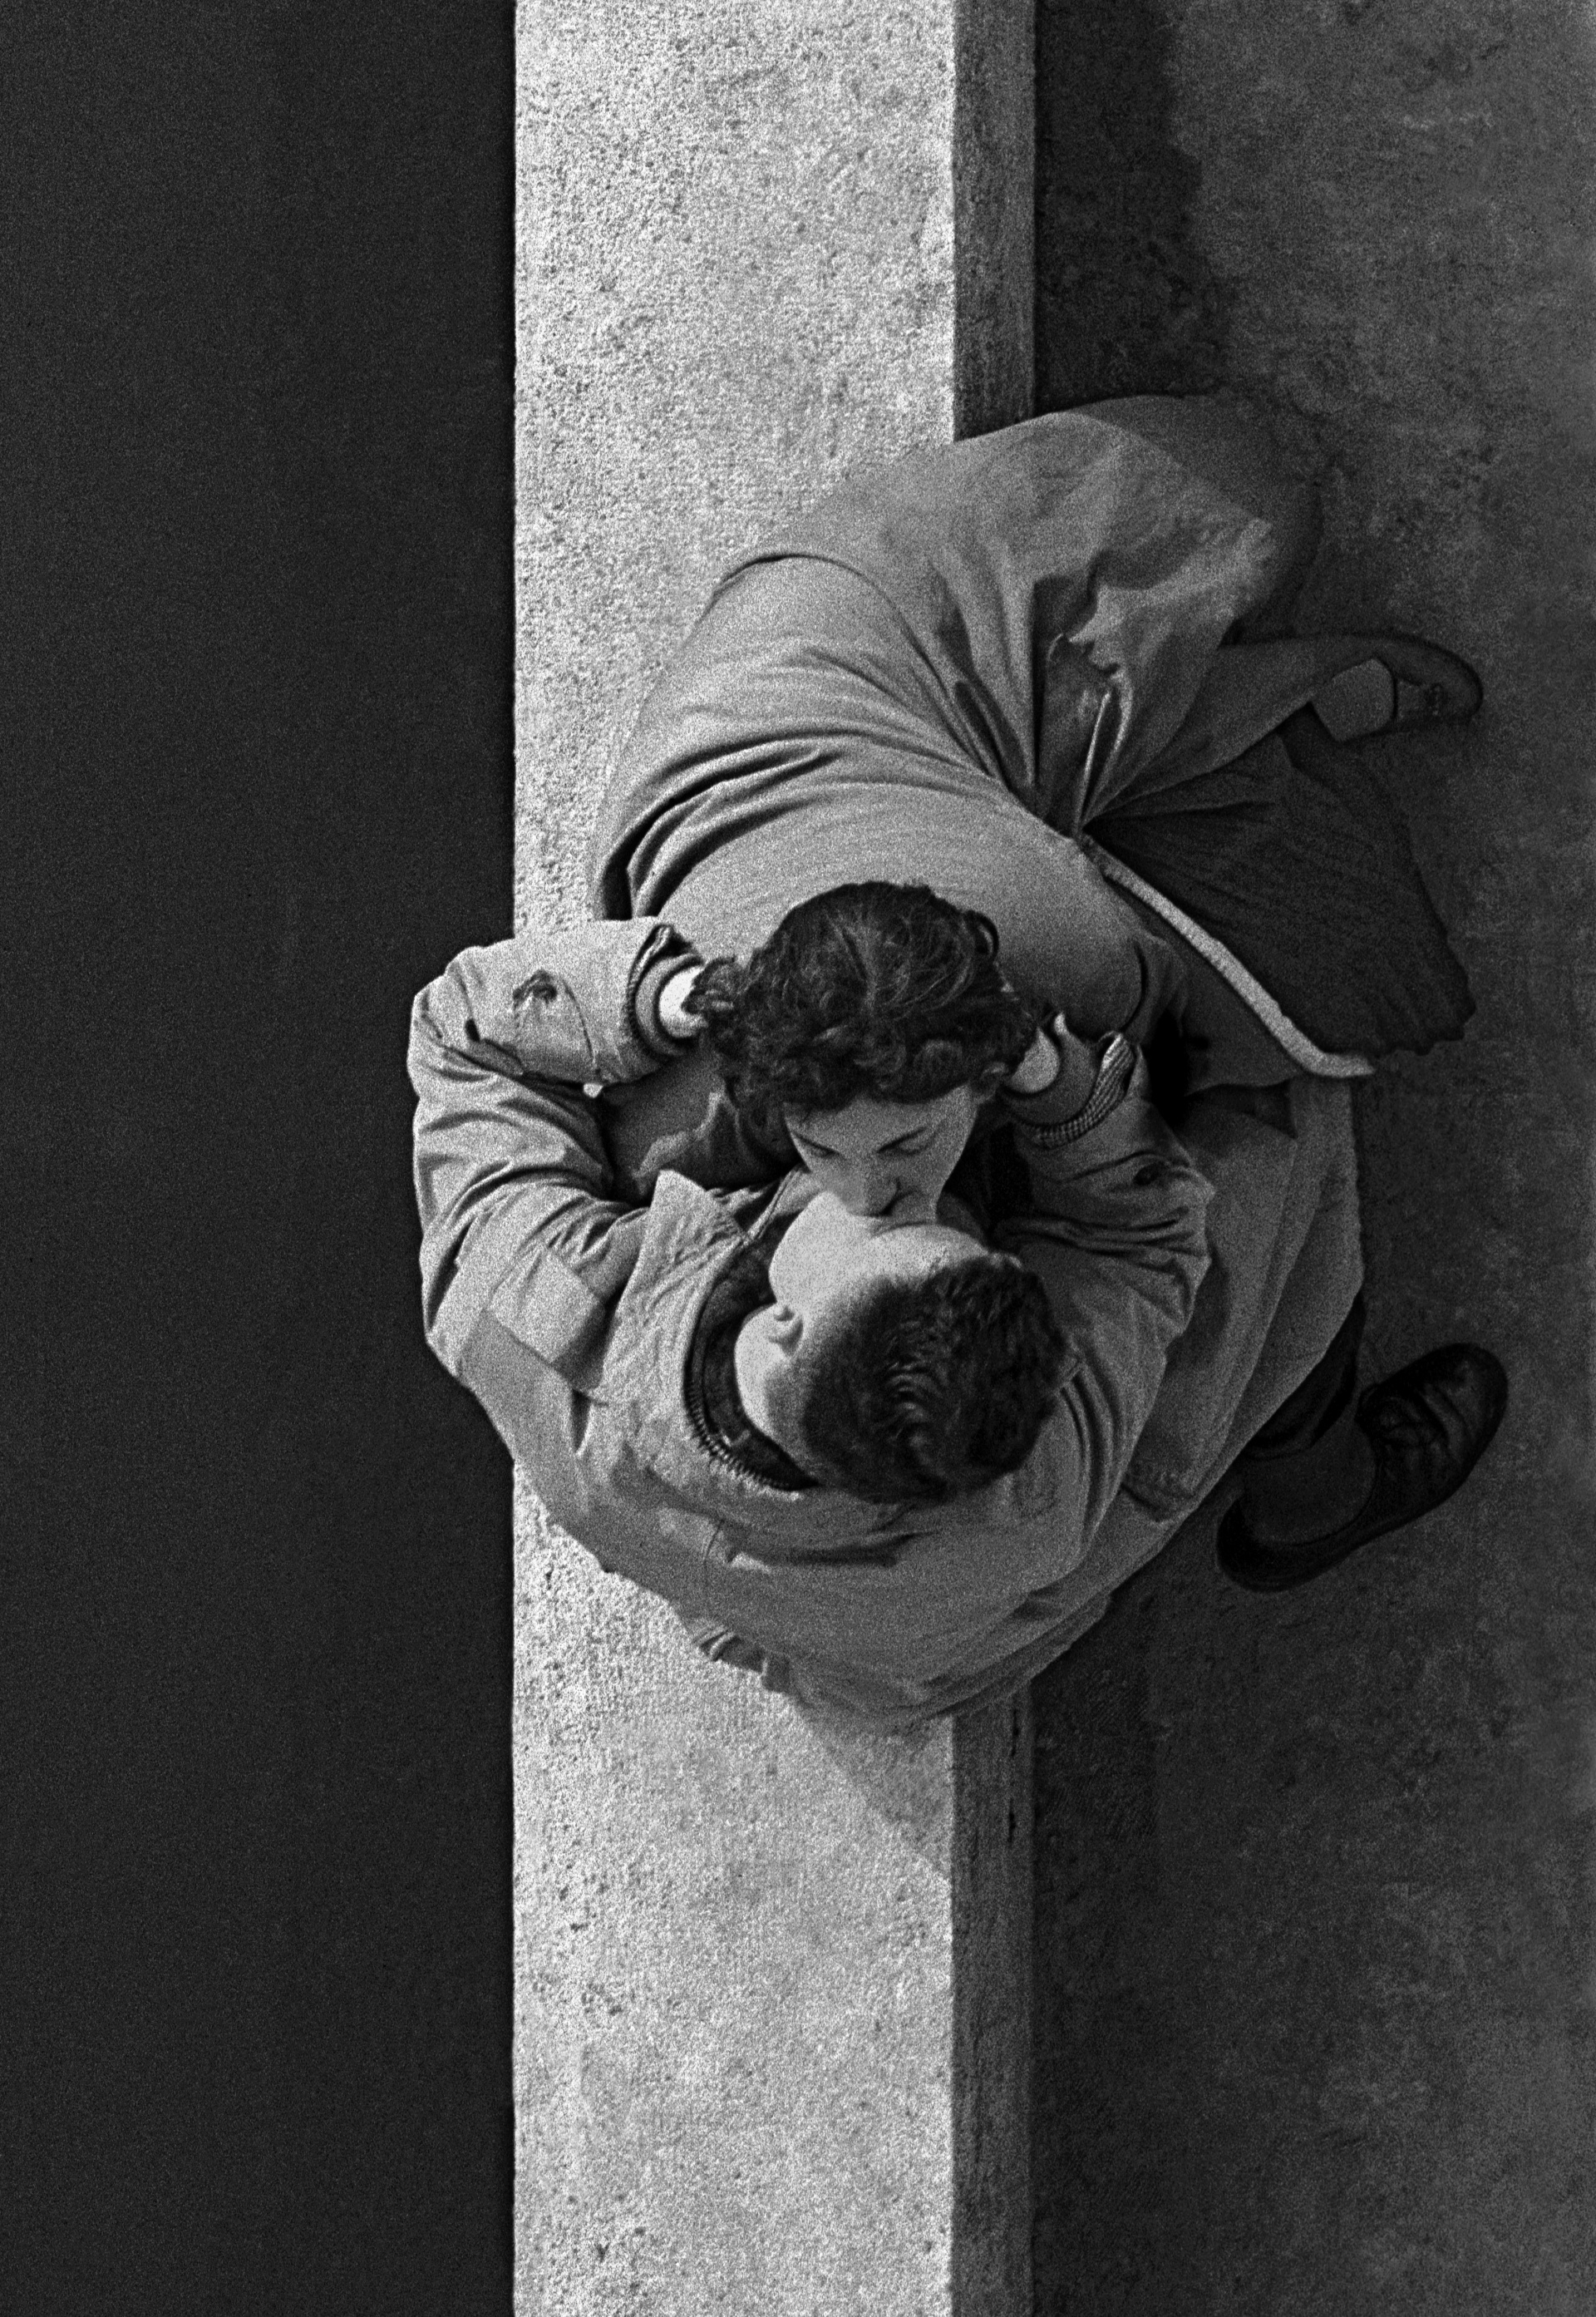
(410, 398), (1505, 1726)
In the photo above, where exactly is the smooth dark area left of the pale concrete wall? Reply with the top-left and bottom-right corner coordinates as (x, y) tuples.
(0, 0), (512, 2317)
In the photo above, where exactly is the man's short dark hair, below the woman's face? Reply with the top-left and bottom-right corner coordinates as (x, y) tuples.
(795, 1254), (1066, 1504)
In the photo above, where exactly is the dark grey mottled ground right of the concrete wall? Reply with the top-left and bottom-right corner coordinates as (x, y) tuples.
(1037, 0), (1596, 2317)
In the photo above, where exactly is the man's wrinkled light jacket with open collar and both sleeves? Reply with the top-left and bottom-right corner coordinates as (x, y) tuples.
(410, 919), (1360, 1728)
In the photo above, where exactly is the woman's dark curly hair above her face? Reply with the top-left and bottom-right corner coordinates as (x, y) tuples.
(688, 883), (1036, 1136)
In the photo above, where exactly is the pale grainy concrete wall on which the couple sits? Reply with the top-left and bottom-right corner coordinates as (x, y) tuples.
(516, 0), (1033, 2317)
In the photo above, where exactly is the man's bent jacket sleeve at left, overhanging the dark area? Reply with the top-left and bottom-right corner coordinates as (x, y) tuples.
(410, 918), (686, 1381)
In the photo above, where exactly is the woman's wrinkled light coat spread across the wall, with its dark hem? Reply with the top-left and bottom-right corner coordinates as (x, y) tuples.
(591, 397), (1471, 1075)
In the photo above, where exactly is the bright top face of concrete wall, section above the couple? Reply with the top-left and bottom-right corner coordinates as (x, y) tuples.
(516, 0), (954, 935)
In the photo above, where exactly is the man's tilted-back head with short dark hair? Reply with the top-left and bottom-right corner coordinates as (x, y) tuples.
(736, 1193), (1066, 1501)
